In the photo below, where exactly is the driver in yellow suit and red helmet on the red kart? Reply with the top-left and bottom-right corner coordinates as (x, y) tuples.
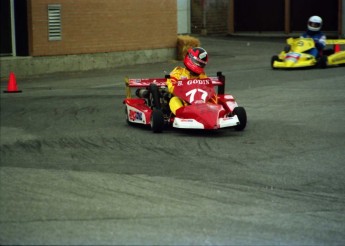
(167, 47), (208, 115)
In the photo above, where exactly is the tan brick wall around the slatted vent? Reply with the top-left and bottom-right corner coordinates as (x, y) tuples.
(28, 0), (177, 56)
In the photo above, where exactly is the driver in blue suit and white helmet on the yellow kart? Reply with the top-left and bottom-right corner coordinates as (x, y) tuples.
(301, 15), (326, 58)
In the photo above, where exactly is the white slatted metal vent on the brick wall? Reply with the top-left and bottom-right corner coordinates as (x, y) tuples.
(48, 4), (62, 41)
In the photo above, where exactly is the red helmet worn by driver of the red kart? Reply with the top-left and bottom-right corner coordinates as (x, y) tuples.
(183, 47), (208, 74)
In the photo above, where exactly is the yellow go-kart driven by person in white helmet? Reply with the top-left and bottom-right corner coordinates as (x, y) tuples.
(271, 38), (345, 69)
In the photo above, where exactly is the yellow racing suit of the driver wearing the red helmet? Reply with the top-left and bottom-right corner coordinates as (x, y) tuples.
(167, 67), (207, 115)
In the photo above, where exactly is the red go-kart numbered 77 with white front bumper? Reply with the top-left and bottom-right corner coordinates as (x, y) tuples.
(123, 72), (247, 133)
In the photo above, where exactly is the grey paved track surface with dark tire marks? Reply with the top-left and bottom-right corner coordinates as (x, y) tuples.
(0, 37), (345, 245)
